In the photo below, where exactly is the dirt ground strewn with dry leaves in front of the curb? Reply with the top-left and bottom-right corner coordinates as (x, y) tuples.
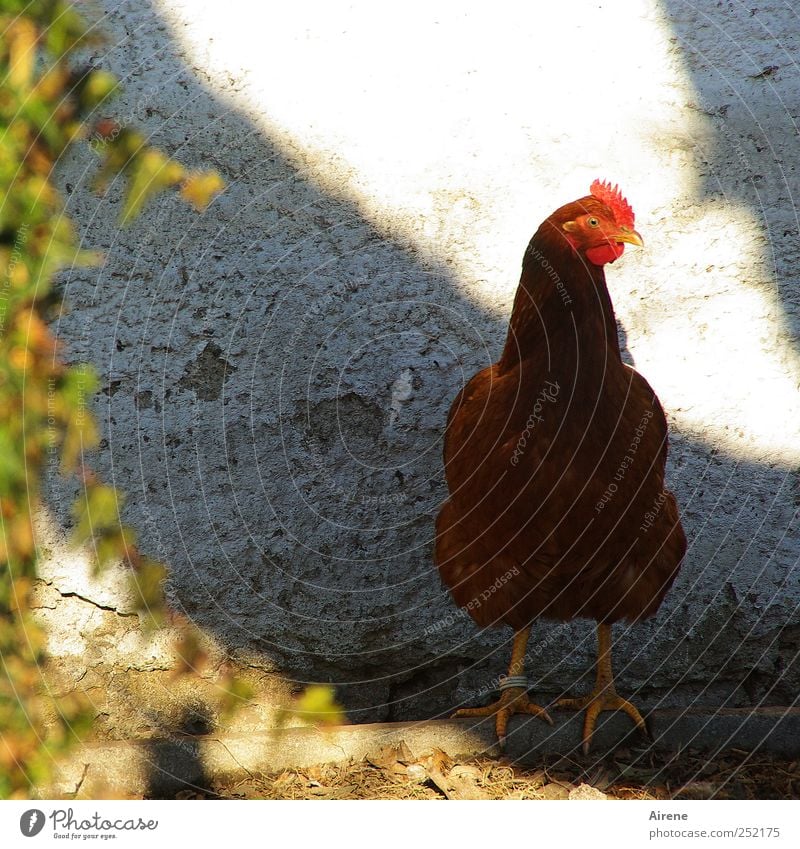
(170, 744), (800, 799)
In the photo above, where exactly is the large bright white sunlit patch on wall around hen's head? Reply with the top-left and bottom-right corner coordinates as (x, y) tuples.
(158, 0), (800, 462)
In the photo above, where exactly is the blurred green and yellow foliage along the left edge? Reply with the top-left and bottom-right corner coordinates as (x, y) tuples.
(0, 0), (234, 798)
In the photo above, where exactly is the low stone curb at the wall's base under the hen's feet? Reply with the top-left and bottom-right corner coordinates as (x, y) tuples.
(42, 708), (800, 798)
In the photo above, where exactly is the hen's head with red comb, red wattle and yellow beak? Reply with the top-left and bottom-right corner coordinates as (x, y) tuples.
(556, 180), (644, 265)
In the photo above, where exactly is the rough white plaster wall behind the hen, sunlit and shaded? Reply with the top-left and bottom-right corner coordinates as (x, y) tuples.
(43, 0), (800, 727)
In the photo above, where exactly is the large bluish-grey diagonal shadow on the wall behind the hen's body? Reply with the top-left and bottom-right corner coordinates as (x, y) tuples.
(53, 3), (800, 721)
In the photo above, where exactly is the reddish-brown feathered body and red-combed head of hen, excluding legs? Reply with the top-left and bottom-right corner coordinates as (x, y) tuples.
(435, 183), (686, 746)
